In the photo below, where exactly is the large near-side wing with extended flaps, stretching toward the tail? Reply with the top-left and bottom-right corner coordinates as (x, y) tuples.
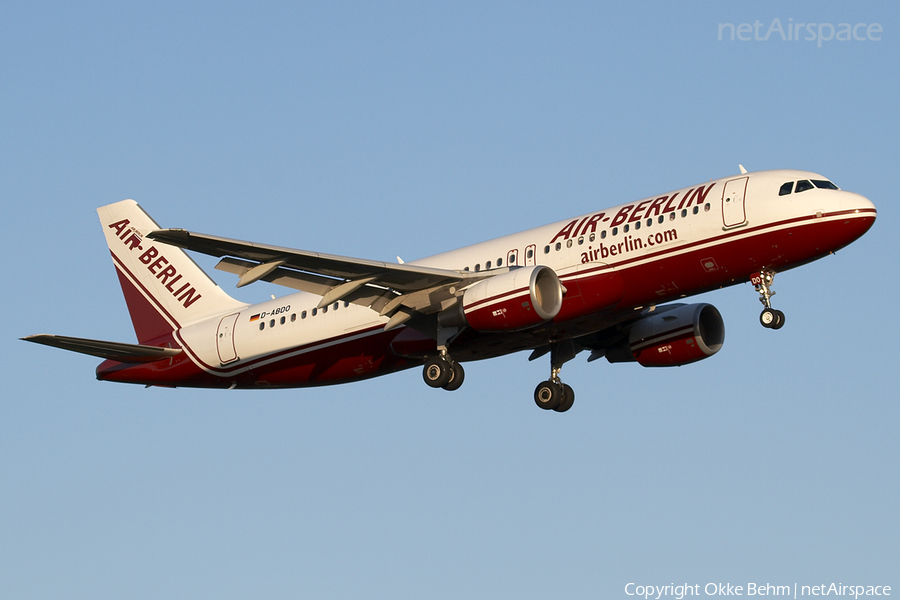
(146, 229), (496, 329)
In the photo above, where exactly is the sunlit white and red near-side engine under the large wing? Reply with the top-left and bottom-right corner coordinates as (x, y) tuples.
(462, 265), (562, 331)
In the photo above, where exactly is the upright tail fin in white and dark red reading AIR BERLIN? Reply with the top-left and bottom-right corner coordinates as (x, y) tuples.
(97, 200), (245, 344)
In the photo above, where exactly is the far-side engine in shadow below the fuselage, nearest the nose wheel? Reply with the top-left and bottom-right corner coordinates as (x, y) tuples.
(606, 304), (725, 367)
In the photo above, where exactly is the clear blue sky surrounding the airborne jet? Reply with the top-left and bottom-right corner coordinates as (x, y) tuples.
(0, 2), (900, 599)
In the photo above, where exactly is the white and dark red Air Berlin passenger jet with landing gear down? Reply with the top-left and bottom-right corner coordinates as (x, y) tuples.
(22, 166), (877, 412)
